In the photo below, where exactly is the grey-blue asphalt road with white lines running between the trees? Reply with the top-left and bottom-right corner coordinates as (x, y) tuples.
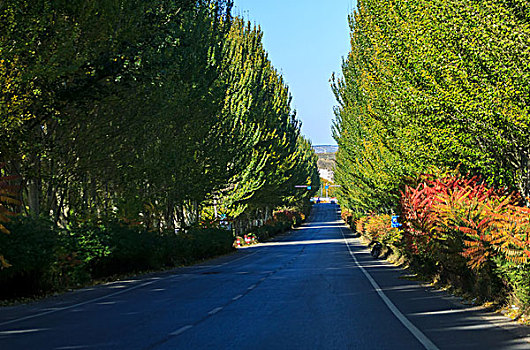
(0, 204), (530, 350)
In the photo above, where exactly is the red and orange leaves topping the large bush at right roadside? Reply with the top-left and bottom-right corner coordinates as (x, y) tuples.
(401, 176), (530, 270)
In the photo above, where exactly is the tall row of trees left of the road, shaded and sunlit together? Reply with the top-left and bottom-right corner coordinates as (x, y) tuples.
(0, 0), (319, 235)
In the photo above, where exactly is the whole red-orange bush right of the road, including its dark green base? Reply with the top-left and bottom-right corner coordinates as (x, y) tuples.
(401, 175), (530, 301)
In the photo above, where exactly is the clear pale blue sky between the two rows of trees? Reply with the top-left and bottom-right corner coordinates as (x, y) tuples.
(233, 0), (356, 145)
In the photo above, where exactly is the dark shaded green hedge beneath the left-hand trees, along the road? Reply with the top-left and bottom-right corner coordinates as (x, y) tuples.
(0, 218), (234, 298)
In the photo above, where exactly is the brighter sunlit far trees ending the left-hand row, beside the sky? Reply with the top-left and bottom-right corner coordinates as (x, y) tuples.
(219, 18), (319, 218)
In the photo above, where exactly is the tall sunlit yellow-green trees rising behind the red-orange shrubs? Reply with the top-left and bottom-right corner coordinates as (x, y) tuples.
(333, 0), (530, 211)
